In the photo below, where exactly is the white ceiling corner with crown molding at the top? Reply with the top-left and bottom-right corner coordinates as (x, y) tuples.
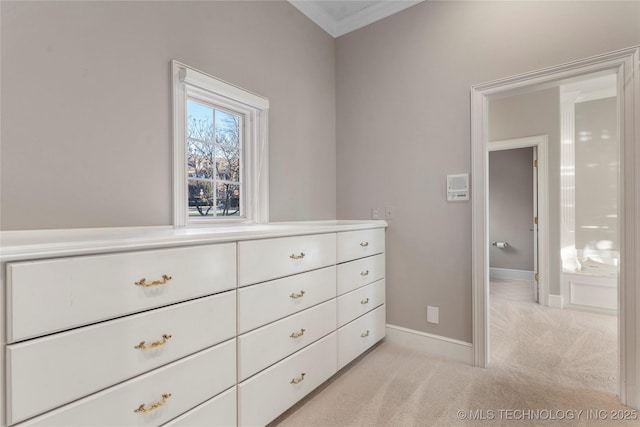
(289, 0), (423, 37)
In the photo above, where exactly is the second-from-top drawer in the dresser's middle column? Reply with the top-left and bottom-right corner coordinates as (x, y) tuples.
(238, 266), (336, 333)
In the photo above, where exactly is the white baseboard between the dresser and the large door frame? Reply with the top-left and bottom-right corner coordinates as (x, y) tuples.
(385, 324), (473, 365)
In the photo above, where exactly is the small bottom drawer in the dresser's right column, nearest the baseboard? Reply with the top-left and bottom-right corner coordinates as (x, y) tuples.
(338, 305), (386, 369)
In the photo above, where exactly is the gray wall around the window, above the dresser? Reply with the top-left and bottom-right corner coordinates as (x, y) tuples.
(0, 1), (336, 230)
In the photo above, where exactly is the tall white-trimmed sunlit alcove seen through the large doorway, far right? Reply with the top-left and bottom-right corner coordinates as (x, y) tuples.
(560, 83), (624, 313)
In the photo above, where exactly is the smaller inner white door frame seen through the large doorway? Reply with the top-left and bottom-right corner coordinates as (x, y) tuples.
(488, 135), (549, 310)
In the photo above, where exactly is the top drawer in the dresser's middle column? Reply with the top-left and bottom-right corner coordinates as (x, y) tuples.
(238, 234), (336, 286)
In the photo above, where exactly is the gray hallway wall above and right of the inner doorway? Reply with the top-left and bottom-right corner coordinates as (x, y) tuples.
(489, 87), (562, 295)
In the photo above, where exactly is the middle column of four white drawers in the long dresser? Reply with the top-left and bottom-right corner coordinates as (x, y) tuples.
(238, 233), (337, 426)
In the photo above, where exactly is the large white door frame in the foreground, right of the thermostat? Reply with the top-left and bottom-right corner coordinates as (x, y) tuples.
(471, 46), (640, 408)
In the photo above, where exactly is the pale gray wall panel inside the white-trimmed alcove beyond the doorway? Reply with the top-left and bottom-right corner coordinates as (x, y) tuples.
(575, 98), (619, 250)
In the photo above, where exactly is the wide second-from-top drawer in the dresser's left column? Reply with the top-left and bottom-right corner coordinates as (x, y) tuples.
(7, 290), (236, 422)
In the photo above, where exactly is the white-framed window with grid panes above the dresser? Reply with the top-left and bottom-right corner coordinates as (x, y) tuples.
(172, 61), (269, 227)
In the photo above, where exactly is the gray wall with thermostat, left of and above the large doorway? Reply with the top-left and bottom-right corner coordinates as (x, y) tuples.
(336, 1), (640, 342)
